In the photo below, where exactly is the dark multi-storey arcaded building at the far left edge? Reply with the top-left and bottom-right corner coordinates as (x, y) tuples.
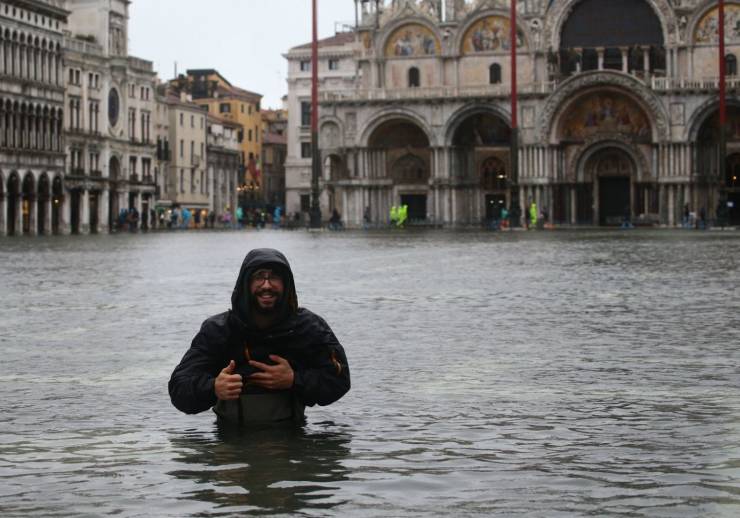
(0, 0), (69, 236)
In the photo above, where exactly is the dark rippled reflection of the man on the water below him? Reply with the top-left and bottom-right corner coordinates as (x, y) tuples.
(169, 425), (350, 514)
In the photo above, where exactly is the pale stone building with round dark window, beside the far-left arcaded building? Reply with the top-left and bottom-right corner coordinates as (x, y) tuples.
(64, 0), (157, 234)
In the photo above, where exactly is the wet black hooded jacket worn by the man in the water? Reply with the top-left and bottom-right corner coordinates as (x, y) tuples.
(169, 249), (350, 414)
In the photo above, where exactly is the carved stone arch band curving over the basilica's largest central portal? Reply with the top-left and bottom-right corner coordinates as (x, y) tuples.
(540, 71), (669, 144)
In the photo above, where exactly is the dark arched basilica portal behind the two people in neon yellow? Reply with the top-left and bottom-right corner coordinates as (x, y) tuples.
(368, 119), (432, 223)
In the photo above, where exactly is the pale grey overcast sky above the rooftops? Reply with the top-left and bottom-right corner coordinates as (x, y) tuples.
(129, 0), (355, 108)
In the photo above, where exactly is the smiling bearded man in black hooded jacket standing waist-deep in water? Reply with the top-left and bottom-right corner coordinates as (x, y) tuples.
(169, 249), (350, 424)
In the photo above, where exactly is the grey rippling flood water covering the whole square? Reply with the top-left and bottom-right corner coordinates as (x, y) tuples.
(0, 230), (740, 517)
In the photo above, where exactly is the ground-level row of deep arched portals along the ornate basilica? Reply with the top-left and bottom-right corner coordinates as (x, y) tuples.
(324, 86), (740, 226)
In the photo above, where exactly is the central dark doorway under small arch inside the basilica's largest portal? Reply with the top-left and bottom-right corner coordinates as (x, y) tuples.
(585, 147), (636, 226)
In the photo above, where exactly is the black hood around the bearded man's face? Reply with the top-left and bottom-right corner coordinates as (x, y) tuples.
(231, 248), (298, 327)
